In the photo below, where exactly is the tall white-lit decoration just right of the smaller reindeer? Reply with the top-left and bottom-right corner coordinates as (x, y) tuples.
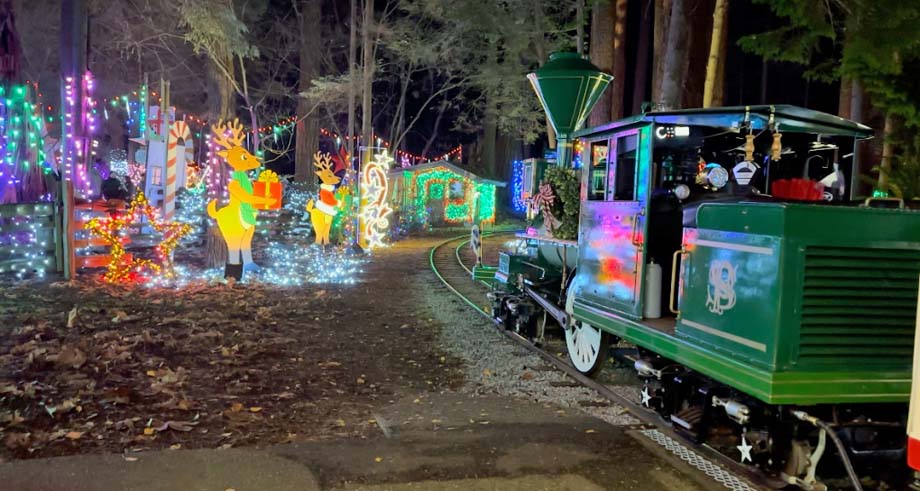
(359, 150), (393, 249)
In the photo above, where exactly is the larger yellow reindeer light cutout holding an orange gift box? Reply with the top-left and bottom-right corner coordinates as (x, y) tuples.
(208, 119), (277, 280)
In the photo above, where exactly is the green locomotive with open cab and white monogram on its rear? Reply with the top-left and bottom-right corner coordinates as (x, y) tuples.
(490, 52), (920, 489)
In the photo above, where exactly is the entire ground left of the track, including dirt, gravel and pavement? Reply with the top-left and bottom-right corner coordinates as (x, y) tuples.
(0, 234), (724, 491)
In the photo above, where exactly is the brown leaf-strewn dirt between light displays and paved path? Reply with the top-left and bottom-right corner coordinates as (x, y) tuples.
(0, 236), (463, 461)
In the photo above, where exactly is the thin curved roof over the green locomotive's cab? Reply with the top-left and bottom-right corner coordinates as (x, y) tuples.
(574, 104), (874, 138)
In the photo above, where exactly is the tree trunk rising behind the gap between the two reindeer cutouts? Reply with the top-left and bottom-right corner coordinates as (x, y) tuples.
(294, 0), (323, 191)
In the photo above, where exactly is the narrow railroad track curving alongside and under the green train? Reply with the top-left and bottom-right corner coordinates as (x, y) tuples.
(429, 232), (773, 491)
